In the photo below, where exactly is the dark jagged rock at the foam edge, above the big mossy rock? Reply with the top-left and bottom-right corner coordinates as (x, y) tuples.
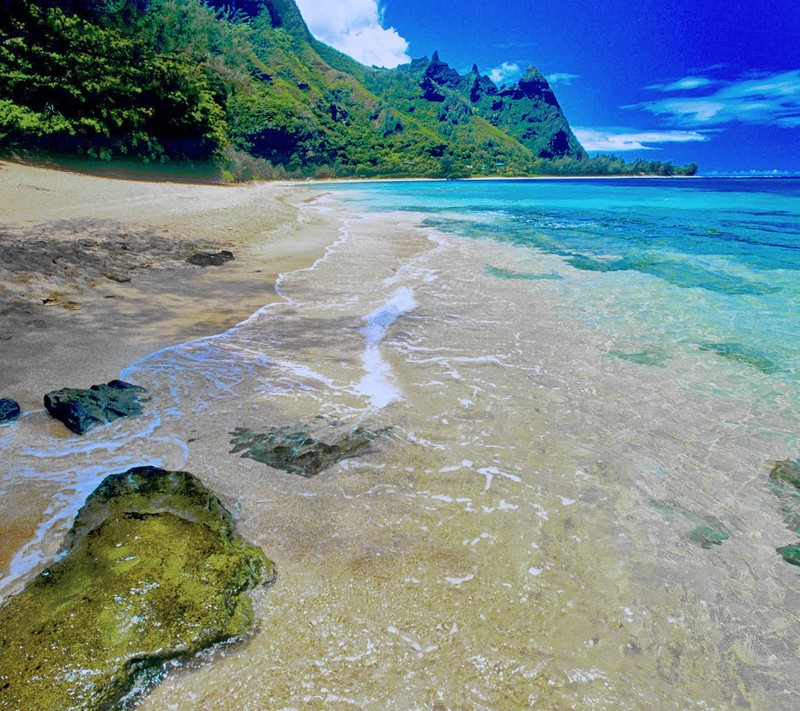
(44, 380), (147, 434)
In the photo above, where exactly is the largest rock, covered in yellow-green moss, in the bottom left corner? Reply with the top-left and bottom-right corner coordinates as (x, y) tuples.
(0, 467), (274, 711)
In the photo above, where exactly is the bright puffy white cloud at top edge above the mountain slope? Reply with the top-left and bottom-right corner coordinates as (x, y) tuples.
(296, 0), (411, 68)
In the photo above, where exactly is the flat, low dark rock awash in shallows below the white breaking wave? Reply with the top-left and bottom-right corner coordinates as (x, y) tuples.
(230, 418), (386, 477)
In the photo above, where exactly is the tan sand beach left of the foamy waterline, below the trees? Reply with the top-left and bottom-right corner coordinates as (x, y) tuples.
(0, 162), (336, 570)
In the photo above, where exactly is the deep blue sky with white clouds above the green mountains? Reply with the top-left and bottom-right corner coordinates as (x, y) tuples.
(298, 0), (800, 174)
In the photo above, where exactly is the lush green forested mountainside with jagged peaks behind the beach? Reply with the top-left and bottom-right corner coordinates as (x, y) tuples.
(0, 0), (696, 179)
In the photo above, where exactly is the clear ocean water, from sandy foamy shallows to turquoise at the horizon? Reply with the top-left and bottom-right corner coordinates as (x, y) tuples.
(0, 178), (800, 709)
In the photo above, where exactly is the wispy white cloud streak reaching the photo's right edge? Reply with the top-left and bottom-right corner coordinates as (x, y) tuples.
(623, 69), (800, 128)
